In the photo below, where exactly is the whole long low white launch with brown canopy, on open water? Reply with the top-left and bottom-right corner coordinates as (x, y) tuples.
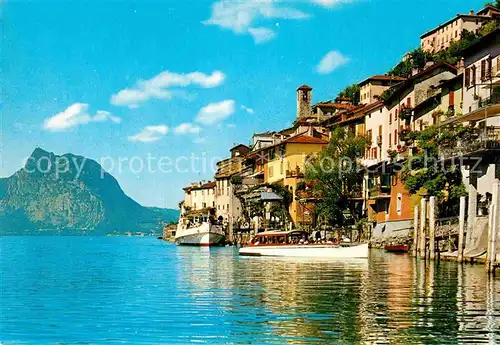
(239, 230), (368, 259)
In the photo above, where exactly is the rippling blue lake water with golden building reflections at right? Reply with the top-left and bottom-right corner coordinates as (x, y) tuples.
(0, 237), (500, 345)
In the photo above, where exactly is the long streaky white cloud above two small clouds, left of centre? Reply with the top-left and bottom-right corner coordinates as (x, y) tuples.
(111, 71), (226, 108)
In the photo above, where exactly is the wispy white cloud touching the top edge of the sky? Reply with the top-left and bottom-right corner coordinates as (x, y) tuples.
(202, 0), (309, 44)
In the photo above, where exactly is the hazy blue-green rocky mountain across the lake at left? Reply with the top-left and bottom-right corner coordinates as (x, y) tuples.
(0, 148), (179, 235)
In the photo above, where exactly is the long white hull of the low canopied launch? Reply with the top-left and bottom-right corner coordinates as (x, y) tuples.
(239, 243), (368, 259)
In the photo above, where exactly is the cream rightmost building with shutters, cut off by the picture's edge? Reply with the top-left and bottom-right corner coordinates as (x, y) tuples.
(440, 29), (500, 235)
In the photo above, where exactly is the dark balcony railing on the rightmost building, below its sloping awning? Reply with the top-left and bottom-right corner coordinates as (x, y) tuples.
(440, 126), (500, 158)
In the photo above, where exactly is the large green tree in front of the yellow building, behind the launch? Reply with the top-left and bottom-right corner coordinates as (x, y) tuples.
(305, 127), (368, 226)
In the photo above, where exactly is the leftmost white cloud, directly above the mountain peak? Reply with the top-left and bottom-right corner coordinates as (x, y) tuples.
(43, 103), (121, 132)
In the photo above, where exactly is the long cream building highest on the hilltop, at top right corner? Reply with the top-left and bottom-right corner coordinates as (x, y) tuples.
(420, 5), (500, 53)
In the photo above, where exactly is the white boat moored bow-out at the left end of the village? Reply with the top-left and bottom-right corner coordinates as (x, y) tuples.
(175, 218), (226, 246)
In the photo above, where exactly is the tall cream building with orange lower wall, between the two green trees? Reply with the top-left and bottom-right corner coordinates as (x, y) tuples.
(362, 63), (461, 237)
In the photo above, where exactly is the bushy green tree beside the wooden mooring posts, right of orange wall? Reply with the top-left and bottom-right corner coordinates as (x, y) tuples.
(403, 125), (469, 216)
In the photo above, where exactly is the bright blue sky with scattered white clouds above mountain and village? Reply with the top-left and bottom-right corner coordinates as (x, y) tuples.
(0, 0), (484, 208)
